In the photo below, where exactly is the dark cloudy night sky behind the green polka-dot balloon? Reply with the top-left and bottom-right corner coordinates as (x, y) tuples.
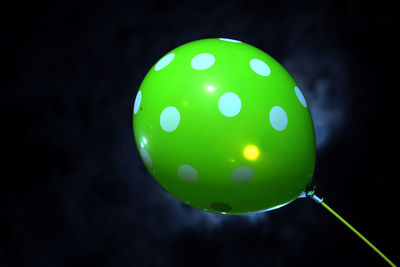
(0, 0), (400, 267)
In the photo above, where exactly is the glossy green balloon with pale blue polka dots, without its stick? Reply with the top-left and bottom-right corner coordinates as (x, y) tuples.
(133, 38), (316, 214)
